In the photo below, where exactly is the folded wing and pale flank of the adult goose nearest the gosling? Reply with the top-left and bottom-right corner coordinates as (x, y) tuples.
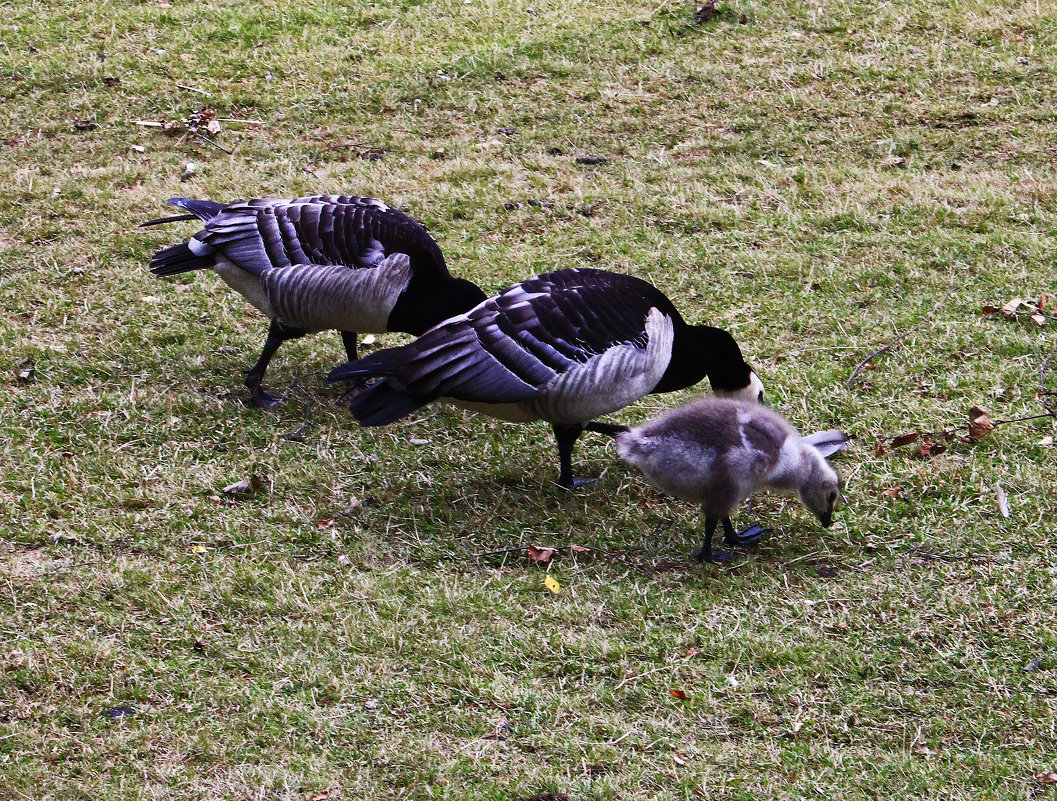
(388, 269), (672, 414)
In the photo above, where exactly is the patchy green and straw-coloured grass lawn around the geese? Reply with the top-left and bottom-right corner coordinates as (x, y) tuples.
(0, 0), (1057, 801)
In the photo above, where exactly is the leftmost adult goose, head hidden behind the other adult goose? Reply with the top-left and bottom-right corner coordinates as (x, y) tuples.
(143, 194), (485, 408)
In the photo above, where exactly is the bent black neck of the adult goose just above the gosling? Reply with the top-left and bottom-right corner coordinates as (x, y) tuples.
(653, 323), (752, 392)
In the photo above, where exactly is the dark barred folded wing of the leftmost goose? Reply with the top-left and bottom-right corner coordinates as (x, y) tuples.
(194, 194), (447, 276)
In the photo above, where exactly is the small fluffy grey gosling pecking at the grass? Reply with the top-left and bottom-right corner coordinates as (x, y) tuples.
(587, 397), (847, 562)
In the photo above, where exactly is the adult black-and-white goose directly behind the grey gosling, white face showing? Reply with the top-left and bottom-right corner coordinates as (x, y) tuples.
(329, 269), (763, 489)
